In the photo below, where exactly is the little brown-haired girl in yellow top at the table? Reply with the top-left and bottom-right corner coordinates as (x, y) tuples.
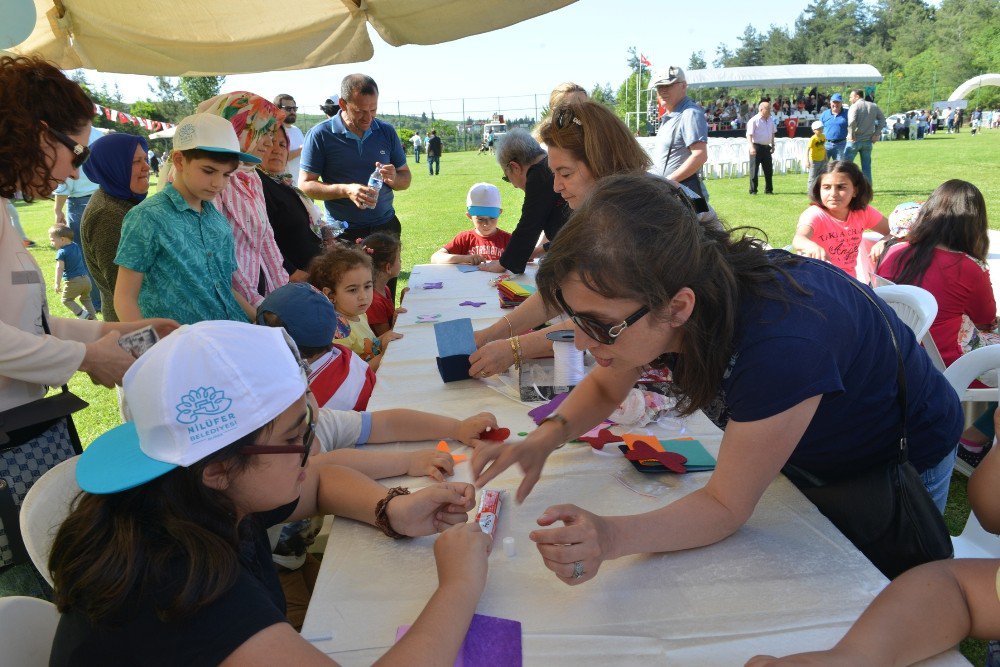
(309, 247), (402, 371)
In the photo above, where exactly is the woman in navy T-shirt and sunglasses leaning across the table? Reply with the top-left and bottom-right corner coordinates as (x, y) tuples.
(472, 175), (963, 584)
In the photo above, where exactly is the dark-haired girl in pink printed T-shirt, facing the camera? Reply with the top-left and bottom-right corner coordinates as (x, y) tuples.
(792, 160), (889, 276)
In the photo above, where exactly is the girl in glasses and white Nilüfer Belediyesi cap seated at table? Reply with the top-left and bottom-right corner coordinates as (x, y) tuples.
(49, 321), (491, 667)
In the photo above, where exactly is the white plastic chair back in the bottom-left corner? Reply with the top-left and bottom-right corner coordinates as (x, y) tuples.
(0, 595), (59, 667)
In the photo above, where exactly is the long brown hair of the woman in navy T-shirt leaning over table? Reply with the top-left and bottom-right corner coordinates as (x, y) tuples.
(537, 174), (801, 414)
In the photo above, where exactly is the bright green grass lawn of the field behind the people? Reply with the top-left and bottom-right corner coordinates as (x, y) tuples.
(9, 130), (1000, 664)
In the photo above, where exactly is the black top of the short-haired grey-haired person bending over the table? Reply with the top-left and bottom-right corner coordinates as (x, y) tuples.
(500, 159), (570, 273)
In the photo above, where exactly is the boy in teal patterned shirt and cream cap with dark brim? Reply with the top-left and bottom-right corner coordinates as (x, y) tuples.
(115, 114), (260, 324)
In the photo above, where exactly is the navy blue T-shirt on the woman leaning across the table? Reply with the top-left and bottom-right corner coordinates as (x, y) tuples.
(705, 253), (963, 476)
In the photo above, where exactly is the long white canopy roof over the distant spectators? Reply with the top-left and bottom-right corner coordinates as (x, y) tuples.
(685, 65), (882, 88)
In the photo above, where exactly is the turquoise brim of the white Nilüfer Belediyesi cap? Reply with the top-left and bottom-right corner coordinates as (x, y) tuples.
(76, 422), (177, 494)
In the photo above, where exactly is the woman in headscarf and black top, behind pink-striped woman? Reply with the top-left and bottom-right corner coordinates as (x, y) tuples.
(257, 125), (323, 280)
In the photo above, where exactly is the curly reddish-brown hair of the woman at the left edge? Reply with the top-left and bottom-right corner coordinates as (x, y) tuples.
(0, 56), (94, 202)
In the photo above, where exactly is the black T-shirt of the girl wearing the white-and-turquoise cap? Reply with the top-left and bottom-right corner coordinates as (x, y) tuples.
(49, 500), (298, 667)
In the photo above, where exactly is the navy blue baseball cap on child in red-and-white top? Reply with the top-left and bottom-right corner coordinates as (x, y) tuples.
(257, 283), (337, 348)
